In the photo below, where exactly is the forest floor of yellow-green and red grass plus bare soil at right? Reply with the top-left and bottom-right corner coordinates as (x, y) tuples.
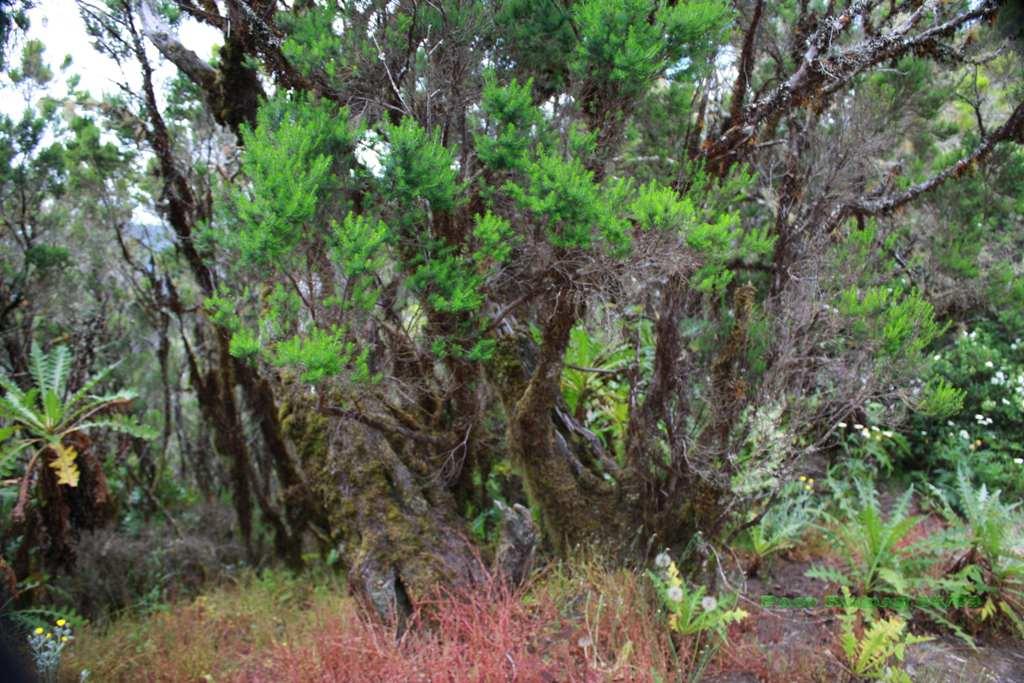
(61, 532), (1024, 683)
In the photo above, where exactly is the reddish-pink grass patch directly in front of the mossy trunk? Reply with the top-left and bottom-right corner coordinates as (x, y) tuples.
(236, 577), (671, 683)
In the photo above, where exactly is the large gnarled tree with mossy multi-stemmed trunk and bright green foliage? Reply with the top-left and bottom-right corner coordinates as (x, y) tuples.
(61, 0), (1024, 613)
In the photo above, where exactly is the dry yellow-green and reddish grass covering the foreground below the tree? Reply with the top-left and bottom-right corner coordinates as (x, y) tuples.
(63, 562), (856, 683)
